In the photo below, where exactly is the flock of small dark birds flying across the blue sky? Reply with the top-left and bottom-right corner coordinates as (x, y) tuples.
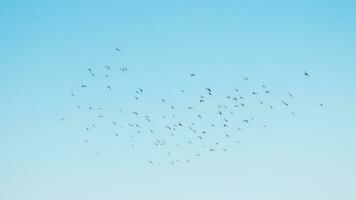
(61, 48), (324, 166)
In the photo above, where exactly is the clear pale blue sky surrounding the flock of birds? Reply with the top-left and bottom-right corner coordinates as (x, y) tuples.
(0, 0), (356, 200)
